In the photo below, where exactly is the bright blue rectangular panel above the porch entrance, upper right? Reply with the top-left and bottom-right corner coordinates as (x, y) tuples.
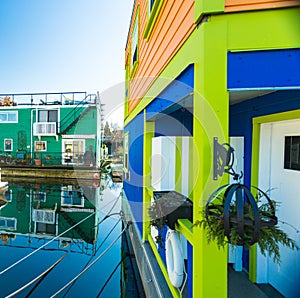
(227, 49), (300, 89)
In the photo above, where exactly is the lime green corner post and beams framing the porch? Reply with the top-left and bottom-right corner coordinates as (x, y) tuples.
(125, 5), (300, 297)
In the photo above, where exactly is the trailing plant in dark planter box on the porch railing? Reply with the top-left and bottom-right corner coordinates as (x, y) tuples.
(148, 191), (193, 247)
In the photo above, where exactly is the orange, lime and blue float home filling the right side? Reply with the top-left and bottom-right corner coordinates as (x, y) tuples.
(123, 0), (300, 298)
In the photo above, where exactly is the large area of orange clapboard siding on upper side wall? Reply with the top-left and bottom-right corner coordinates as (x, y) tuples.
(126, 0), (195, 113)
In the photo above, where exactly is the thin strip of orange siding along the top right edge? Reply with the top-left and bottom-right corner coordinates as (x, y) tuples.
(225, 0), (300, 12)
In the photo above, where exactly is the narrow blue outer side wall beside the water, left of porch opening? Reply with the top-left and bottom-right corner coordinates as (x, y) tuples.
(123, 113), (144, 235)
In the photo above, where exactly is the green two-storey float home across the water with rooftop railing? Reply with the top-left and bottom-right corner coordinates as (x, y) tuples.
(0, 92), (101, 166)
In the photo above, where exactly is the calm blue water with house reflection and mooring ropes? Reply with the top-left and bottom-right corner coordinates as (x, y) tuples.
(0, 181), (126, 298)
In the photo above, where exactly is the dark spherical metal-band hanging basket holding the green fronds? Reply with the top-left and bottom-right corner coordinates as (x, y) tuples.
(205, 183), (277, 246)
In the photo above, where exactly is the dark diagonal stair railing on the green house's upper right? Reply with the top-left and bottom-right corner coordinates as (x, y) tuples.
(59, 94), (97, 134)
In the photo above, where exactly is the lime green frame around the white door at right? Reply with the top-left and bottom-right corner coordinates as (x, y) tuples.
(249, 109), (300, 282)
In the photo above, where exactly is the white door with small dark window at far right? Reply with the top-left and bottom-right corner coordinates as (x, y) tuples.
(257, 120), (300, 297)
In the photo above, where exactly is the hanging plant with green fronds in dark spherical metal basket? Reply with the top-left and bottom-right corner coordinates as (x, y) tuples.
(195, 183), (299, 263)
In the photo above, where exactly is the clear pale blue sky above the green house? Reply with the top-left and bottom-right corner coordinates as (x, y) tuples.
(0, 0), (134, 123)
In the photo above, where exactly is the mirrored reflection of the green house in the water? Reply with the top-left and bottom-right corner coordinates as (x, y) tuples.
(0, 181), (101, 254)
